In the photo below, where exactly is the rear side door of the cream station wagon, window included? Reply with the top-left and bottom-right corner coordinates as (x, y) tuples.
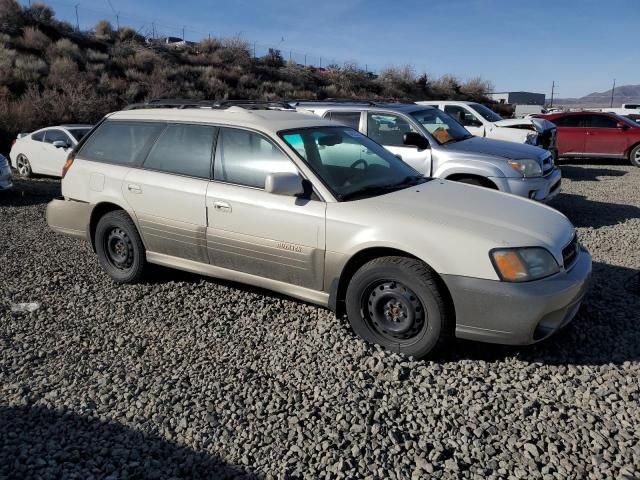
(122, 123), (216, 263)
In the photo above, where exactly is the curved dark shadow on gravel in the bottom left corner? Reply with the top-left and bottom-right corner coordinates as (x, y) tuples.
(0, 406), (258, 479)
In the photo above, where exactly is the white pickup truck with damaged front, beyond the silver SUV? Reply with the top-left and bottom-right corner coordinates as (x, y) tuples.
(416, 100), (557, 158)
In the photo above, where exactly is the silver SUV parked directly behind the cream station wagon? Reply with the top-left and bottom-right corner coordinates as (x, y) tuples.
(292, 101), (562, 202)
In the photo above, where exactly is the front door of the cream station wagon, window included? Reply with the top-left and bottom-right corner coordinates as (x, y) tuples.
(207, 128), (326, 290)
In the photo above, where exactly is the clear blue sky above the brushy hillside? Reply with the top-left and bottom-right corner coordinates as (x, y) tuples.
(30, 0), (640, 97)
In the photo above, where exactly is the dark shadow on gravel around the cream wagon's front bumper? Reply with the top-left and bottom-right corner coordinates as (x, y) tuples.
(438, 262), (640, 365)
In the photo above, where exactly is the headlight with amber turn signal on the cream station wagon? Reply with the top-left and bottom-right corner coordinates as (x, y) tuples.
(489, 247), (560, 282)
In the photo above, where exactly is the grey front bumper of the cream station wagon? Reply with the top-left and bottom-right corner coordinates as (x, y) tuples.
(443, 249), (591, 345)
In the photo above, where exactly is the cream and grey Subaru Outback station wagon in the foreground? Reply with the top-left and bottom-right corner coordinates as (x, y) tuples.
(47, 99), (591, 357)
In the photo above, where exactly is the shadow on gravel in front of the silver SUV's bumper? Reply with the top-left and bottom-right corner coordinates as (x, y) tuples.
(549, 193), (640, 228)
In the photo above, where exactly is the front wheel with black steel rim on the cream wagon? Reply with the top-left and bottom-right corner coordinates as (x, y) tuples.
(345, 257), (453, 358)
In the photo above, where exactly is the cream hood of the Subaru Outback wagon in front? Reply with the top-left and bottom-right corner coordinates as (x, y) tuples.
(359, 179), (575, 262)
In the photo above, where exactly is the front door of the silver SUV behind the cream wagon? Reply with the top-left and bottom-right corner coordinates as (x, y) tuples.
(365, 111), (431, 175)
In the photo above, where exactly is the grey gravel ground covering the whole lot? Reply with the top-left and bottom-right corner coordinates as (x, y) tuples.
(0, 162), (640, 479)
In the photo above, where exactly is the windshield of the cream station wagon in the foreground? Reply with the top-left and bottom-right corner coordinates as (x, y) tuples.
(280, 127), (427, 201)
